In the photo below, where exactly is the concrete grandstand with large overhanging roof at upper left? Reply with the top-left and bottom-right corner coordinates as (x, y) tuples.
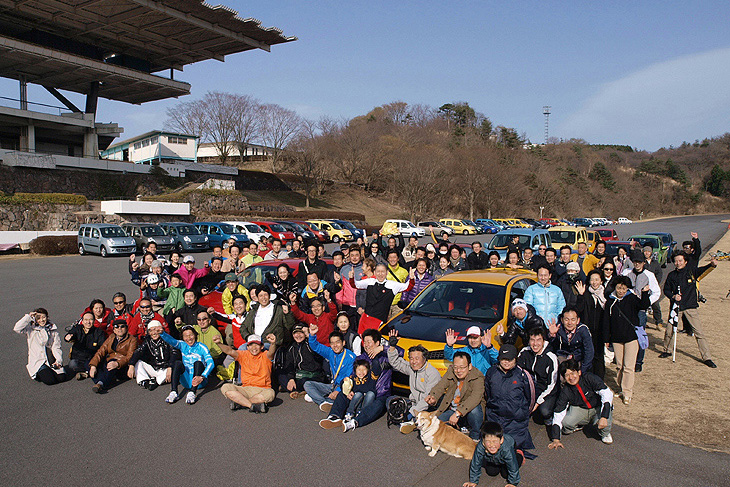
(0, 0), (296, 174)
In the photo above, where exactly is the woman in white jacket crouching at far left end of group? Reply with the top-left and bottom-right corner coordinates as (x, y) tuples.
(13, 308), (66, 386)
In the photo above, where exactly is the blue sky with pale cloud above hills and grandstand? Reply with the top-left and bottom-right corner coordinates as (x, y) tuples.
(0, 0), (730, 150)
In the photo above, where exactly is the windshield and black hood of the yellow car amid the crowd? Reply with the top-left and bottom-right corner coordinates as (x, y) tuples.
(394, 281), (505, 341)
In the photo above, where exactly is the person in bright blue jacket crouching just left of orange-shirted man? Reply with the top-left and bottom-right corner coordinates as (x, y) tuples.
(160, 325), (214, 404)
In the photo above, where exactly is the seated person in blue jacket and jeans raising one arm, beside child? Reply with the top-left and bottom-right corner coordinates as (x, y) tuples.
(304, 324), (355, 412)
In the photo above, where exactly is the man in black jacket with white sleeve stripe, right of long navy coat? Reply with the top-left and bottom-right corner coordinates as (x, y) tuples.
(517, 326), (558, 426)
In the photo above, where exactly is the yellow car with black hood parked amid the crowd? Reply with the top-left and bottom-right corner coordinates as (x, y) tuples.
(381, 269), (537, 389)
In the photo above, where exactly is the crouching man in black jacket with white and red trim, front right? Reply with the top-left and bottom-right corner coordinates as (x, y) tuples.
(548, 359), (613, 450)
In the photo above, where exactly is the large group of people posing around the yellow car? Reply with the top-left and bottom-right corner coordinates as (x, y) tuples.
(14, 230), (717, 486)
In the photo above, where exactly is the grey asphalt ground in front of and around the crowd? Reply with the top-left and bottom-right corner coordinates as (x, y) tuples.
(0, 215), (730, 486)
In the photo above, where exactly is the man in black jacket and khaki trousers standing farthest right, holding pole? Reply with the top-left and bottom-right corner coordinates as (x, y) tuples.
(659, 254), (717, 369)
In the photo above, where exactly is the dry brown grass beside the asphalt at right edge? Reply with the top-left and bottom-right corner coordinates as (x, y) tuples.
(606, 232), (730, 452)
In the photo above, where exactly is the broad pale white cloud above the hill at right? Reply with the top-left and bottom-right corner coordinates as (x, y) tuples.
(558, 48), (730, 150)
